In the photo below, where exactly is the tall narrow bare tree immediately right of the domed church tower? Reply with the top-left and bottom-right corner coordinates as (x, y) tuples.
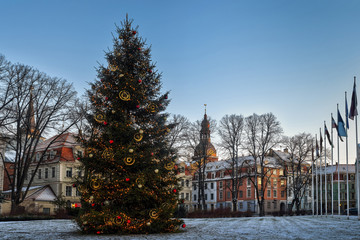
(218, 114), (244, 211)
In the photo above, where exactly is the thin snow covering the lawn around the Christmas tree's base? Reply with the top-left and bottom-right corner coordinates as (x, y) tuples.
(0, 216), (360, 240)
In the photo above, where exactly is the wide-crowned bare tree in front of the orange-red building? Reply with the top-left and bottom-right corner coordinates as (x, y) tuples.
(244, 113), (282, 216)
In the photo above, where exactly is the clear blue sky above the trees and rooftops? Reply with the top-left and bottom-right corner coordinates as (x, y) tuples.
(0, 0), (360, 159)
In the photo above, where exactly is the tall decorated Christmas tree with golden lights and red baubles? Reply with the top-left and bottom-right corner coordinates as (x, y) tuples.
(76, 17), (185, 234)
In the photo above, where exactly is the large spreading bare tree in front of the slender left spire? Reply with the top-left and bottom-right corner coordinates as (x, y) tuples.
(0, 60), (83, 213)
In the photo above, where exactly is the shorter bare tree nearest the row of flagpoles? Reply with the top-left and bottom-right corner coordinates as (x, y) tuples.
(284, 133), (314, 214)
